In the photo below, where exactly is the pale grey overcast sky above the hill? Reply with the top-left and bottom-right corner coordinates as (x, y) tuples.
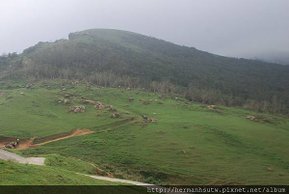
(0, 0), (289, 58)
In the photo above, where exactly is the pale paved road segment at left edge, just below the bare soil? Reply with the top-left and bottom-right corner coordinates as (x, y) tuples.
(0, 149), (45, 165)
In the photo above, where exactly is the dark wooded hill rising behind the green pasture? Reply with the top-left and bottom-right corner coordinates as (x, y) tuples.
(0, 29), (289, 113)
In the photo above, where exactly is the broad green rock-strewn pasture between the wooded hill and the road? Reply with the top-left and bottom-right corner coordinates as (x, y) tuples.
(0, 81), (289, 184)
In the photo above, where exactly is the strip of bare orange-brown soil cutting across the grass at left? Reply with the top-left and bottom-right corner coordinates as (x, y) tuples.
(0, 129), (94, 150)
